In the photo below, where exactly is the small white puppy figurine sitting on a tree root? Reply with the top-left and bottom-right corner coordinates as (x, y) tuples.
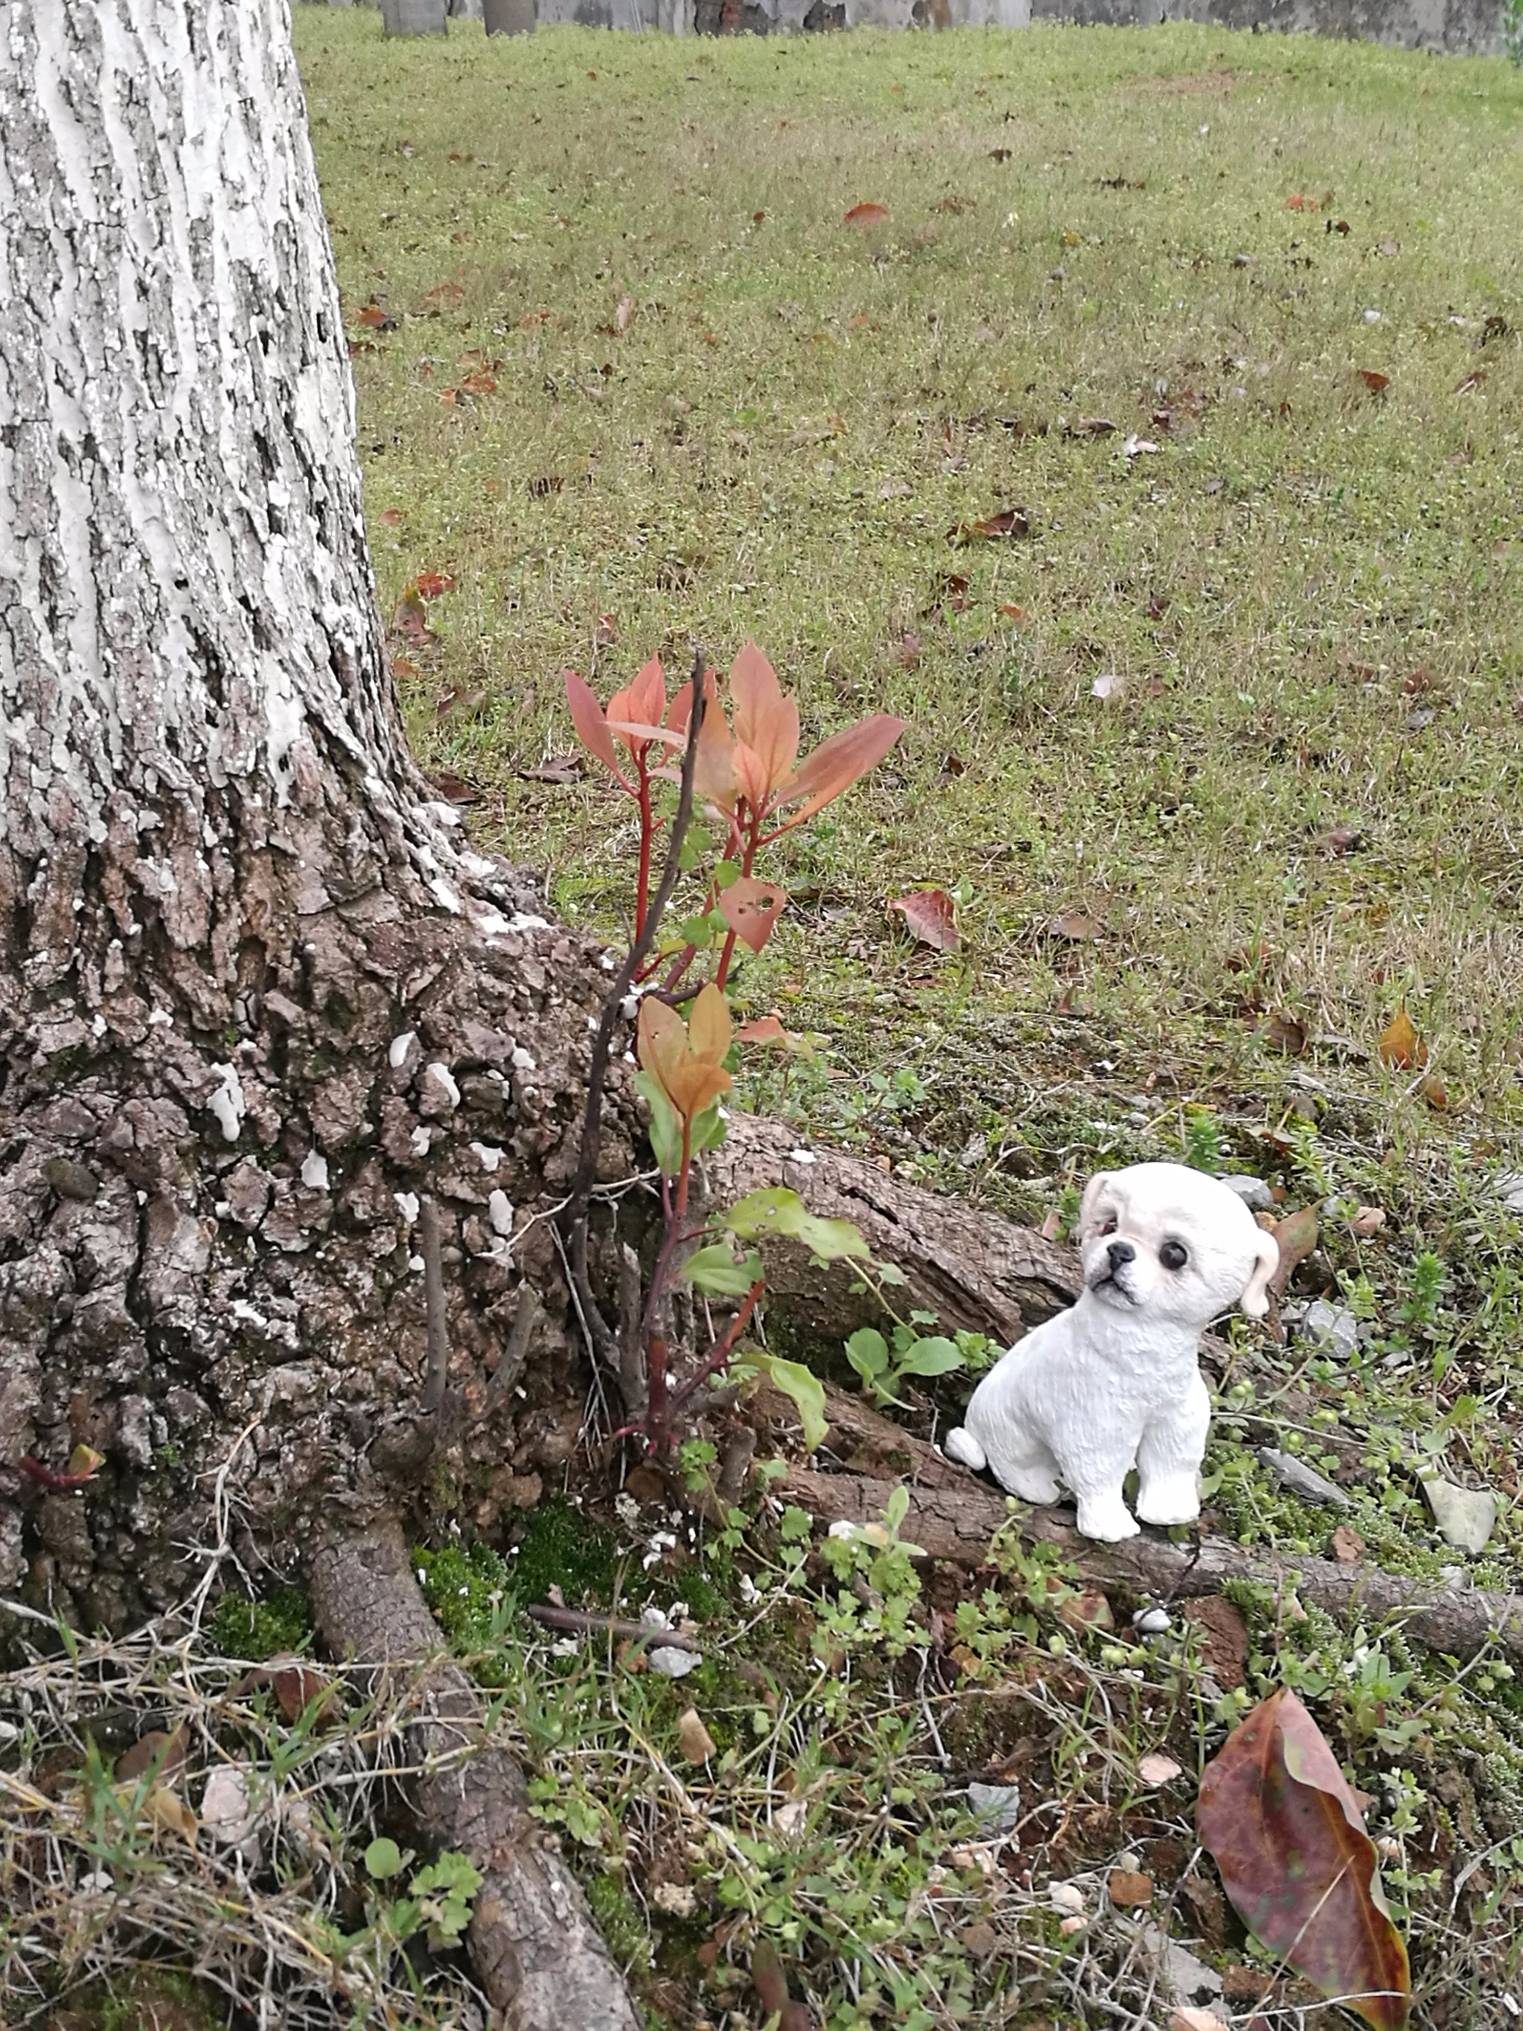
(946, 1164), (1279, 1544)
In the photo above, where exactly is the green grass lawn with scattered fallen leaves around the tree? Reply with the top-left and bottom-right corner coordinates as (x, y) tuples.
(11, 23), (1523, 2031)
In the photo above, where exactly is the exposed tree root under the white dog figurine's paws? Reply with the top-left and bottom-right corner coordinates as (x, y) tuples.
(762, 1389), (1523, 1663)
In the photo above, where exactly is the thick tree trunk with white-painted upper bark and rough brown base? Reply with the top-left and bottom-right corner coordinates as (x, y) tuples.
(0, 0), (645, 1625)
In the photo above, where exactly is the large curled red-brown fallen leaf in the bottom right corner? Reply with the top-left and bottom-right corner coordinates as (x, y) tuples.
(1196, 1686), (1411, 2031)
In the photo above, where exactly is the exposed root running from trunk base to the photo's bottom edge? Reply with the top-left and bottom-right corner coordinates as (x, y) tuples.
(309, 1519), (638, 2031)
